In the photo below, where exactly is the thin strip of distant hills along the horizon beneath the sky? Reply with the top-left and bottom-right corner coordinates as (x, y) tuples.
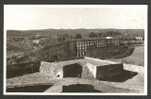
(7, 29), (144, 36)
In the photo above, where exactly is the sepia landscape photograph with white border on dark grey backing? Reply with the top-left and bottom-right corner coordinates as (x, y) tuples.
(3, 4), (148, 95)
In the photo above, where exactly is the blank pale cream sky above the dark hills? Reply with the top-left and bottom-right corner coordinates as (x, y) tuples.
(4, 5), (147, 30)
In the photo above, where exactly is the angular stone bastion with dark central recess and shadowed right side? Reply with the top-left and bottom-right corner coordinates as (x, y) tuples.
(40, 57), (123, 80)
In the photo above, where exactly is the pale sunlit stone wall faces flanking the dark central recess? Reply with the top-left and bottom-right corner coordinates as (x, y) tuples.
(39, 61), (96, 79)
